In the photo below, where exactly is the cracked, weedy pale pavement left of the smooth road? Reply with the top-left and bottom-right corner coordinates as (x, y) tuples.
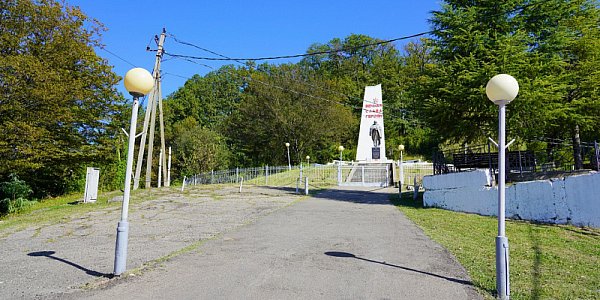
(0, 186), (301, 299)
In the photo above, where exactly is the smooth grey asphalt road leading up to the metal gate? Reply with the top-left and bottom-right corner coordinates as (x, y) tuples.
(65, 188), (480, 299)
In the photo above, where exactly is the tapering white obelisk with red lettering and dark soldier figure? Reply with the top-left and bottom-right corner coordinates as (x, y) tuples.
(356, 84), (387, 162)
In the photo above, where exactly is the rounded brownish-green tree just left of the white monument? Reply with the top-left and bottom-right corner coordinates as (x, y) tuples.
(227, 65), (356, 165)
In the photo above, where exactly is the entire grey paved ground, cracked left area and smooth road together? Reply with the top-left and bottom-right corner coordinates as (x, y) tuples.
(0, 186), (480, 299)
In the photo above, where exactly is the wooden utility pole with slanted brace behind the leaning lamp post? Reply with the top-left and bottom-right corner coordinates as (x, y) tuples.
(133, 28), (166, 190)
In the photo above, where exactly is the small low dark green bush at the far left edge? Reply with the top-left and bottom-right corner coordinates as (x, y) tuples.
(0, 174), (35, 215)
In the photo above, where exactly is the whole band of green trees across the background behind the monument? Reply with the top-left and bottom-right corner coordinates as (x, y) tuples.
(0, 0), (600, 211)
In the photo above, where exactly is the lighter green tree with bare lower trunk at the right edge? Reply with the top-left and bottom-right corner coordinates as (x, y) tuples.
(519, 0), (600, 169)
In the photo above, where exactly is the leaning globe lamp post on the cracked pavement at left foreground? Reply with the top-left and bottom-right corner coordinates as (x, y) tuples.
(114, 68), (154, 275)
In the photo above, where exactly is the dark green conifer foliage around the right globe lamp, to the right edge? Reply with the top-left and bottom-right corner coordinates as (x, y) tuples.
(422, 0), (600, 159)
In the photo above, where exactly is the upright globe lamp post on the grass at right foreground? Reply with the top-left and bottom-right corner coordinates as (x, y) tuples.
(485, 74), (519, 299)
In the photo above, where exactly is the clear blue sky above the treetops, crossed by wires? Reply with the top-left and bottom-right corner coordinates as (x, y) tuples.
(67, 0), (441, 96)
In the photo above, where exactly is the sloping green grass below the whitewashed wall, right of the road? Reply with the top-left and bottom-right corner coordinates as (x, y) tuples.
(391, 193), (600, 299)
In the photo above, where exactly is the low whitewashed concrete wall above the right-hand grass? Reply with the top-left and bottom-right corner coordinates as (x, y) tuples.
(423, 170), (600, 228)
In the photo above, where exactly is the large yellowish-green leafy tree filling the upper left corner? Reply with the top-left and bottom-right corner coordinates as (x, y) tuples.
(0, 0), (122, 195)
